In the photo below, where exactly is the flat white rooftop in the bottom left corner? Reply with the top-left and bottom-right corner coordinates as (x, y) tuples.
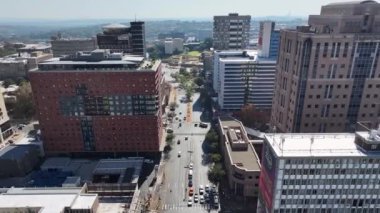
(0, 188), (97, 213)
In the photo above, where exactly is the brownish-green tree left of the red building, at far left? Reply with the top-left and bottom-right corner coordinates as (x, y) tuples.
(14, 82), (35, 119)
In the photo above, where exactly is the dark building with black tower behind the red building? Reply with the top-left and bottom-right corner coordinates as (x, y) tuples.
(97, 21), (145, 57)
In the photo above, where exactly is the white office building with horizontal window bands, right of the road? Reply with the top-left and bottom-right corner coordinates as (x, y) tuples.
(213, 50), (276, 110)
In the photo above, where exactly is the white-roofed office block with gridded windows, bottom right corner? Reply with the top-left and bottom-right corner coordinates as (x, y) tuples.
(257, 127), (380, 213)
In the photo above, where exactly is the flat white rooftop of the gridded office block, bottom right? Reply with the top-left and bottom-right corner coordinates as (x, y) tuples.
(265, 132), (379, 157)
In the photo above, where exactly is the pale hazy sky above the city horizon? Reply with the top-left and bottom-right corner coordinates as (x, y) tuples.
(0, 0), (354, 19)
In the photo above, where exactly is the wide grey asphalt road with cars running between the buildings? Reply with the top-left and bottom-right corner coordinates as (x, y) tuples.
(160, 64), (215, 213)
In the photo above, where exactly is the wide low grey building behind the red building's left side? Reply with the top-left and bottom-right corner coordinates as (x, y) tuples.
(50, 37), (97, 57)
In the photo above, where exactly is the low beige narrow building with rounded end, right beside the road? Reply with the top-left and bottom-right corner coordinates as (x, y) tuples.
(219, 117), (261, 198)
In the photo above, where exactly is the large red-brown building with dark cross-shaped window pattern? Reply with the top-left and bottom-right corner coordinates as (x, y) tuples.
(29, 50), (162, 154)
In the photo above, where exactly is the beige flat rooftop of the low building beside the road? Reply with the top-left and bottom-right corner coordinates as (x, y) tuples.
(219, 117), (260, 171)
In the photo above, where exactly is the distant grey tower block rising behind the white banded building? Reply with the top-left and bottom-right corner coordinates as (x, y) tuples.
(213, 13), (251, 50)
